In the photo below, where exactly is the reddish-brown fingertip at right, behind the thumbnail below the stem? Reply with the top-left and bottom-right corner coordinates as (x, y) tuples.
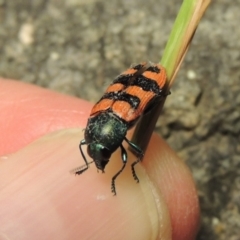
(143, 134), (200, 240)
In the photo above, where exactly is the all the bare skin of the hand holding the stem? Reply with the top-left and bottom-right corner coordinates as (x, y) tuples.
(0, 79), (199, 240)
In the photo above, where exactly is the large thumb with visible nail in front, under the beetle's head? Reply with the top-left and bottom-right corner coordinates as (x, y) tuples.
(0, 129), (171, 240)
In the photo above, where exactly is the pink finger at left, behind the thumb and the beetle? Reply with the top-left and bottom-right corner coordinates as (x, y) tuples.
(0, 79), (92, 155)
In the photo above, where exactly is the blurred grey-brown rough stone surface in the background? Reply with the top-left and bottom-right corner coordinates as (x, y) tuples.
(0, 0), (240, 240)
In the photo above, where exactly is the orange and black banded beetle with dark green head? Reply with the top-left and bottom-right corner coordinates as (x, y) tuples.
(75, 62), (167, 195)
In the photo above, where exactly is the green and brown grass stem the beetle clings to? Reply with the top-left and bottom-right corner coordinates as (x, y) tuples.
(132, 0), (211, 152)
